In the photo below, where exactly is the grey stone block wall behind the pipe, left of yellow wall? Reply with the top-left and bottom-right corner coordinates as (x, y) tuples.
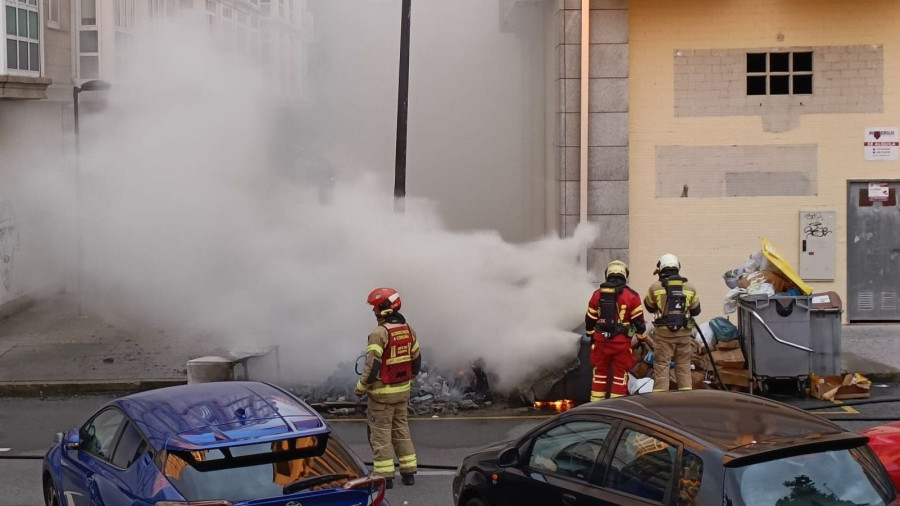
(557, 0), (628, 279)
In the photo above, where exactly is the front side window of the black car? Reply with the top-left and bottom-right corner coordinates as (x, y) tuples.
(528, 420), (611, 481)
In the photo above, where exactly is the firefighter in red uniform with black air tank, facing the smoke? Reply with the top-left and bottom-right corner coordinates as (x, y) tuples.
(584, 260), (646, 401)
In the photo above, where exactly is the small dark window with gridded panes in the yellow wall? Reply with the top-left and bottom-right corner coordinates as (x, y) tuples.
(747, 51), (813, 95)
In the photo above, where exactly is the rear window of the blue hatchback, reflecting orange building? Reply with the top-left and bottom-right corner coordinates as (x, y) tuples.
(163, 436), (366, 502)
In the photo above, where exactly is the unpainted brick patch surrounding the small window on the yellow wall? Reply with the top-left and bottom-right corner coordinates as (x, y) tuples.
(673, 44), (884, 132)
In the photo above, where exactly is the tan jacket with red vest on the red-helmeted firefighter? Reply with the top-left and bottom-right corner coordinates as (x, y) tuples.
(356, 314), (422, 403)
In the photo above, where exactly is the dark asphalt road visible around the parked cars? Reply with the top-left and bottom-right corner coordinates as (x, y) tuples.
(0, 390), (900, 506)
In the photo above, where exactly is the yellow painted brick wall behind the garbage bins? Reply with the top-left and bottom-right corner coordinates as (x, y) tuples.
(629, 0), (900, 321)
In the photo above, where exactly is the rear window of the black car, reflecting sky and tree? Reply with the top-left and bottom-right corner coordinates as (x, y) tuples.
(725, 447), (895, 506)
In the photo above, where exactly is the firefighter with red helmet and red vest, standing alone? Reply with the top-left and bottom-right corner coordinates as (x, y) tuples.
(355, 288), (422, 488)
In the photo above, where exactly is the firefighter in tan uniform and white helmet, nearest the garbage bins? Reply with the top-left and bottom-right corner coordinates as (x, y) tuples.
(644, 253), (700, 391)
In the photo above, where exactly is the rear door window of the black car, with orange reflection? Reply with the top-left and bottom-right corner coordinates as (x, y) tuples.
(602, 429), (678, 502)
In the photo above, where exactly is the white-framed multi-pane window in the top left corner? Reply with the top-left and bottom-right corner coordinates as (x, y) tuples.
(4, 0), (41, 74)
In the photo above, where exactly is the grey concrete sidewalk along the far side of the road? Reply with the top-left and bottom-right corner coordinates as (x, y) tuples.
(0, 295), (900, 396)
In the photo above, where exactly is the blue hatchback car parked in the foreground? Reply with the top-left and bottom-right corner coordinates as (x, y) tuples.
(43, 381), (387, 506)
